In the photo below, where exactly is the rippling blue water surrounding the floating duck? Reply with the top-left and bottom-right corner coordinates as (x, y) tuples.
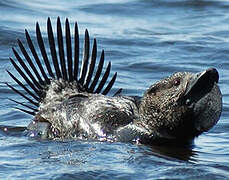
(0, 0), (229, 179)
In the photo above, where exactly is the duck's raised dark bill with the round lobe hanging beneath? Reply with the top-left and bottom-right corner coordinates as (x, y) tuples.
(184, 68), (222, 136)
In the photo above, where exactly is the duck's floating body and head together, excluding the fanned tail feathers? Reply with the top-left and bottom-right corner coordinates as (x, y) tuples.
(28, 69), (222, 144)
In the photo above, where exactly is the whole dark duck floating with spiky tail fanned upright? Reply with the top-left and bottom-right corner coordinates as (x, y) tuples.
(7, 18), (222, 143)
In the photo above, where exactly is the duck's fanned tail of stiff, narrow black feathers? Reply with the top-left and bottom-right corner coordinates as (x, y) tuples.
(6, 17), (121, 115)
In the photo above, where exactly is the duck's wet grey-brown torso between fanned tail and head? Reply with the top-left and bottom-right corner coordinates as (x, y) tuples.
(28, 80), (138, 141)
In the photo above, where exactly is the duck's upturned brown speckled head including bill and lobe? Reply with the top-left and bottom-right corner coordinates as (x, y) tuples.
(139, 68), (222, 140)
